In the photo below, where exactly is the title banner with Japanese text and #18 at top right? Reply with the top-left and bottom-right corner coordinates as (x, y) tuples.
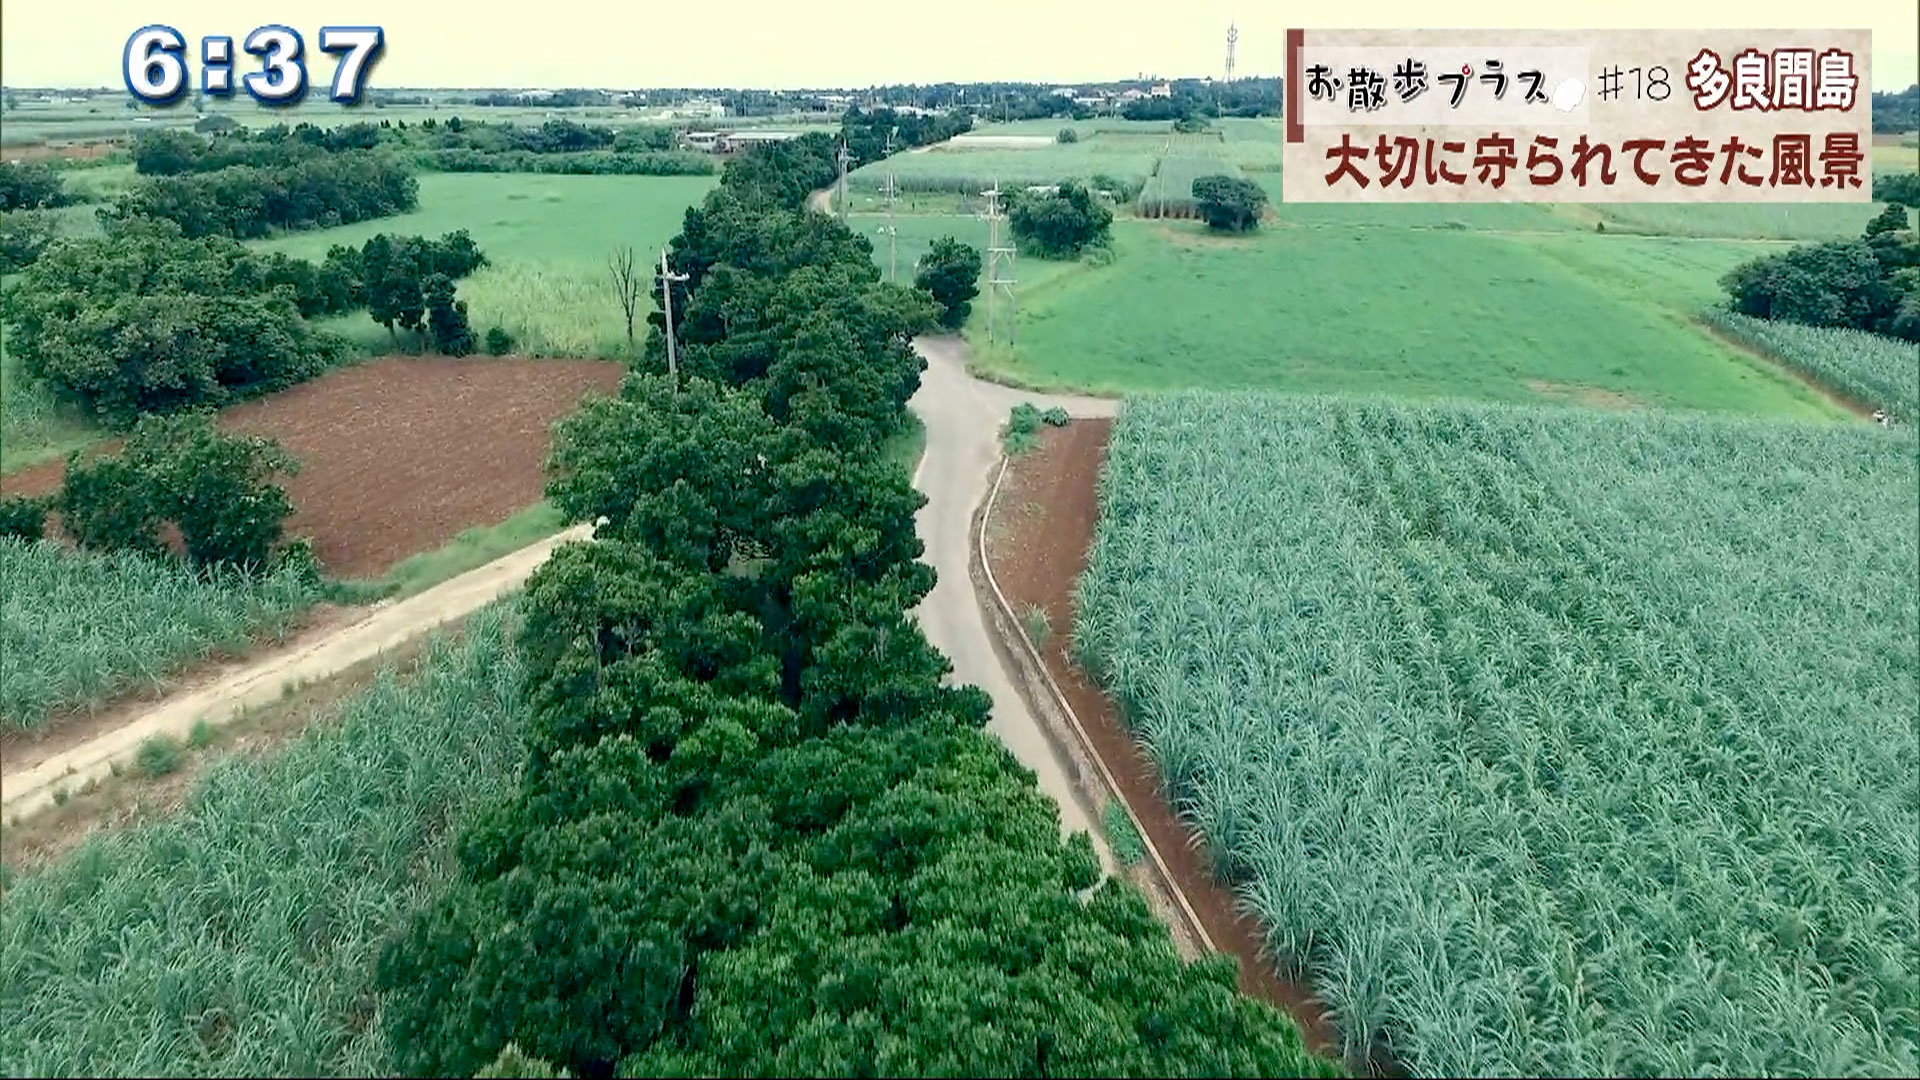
(1281, 29), (1872, 202)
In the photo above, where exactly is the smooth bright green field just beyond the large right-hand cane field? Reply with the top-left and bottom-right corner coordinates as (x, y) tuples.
(972, 215), (1839, 417)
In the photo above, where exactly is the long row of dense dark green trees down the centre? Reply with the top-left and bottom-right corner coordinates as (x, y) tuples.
(378, 136), (1329, 1076)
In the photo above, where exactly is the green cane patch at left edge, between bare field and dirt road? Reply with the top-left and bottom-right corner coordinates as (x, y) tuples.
(0, 538), (319, 730)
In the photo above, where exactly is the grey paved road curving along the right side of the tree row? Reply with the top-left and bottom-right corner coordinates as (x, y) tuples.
(912, 338), (1119, 849)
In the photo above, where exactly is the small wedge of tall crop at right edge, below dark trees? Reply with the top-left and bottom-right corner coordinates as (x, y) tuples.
(1707, 311), (1920, 423)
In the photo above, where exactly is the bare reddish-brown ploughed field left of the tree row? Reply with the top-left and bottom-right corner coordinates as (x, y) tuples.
(0, 356), (624, 578)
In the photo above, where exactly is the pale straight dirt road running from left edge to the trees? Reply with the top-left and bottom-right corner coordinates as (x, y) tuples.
(0, 525), (591, 822)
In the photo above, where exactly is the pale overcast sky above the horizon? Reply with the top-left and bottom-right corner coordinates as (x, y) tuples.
(0, 0), (1920, 90)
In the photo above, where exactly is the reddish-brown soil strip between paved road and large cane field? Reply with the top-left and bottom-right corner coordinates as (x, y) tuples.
(985, 419), (1340, 1057)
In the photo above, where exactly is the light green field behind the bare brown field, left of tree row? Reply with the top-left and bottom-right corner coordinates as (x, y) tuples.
(257, 173), (714, 357)
